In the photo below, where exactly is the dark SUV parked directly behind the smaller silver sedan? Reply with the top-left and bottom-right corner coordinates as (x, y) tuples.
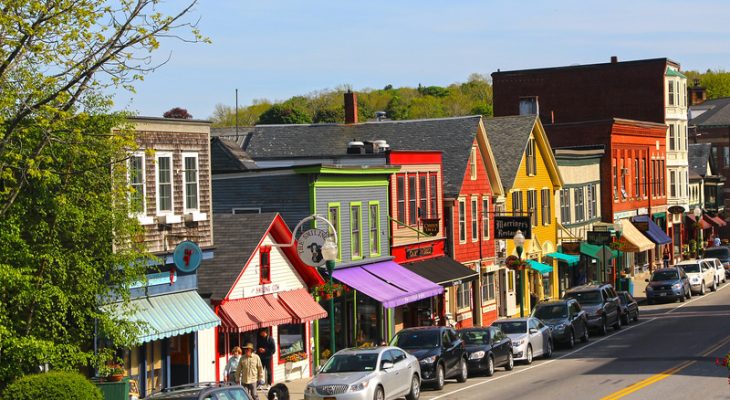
(530, 298), (588, 348)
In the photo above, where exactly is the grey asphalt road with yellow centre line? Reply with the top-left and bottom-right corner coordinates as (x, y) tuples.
(421, 282), (730, 400)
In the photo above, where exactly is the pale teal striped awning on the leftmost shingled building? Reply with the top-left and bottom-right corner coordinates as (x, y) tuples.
(106, 290), (221, 343)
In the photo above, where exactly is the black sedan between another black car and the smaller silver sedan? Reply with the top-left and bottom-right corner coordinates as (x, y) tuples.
(458, 326), (515, 376)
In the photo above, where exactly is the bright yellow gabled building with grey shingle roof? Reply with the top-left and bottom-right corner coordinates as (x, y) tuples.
(485, 115), (563, 315)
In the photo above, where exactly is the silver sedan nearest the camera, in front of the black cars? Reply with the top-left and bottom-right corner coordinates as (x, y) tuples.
(304, 346), (421, 400)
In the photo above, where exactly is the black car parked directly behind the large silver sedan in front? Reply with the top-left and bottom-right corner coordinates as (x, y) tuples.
(390, 326), (468, 390)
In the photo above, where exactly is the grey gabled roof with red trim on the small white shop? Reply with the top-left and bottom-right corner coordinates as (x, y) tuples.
(198, 213), (322, 301)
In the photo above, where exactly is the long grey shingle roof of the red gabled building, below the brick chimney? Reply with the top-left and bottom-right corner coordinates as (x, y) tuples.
(213, 115), (491, 198)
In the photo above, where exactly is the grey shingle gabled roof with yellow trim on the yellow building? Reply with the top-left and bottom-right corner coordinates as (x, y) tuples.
(484, 115), (563, 190)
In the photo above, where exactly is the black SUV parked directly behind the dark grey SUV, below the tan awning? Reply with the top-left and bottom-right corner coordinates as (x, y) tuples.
(563, 283), (621, 335)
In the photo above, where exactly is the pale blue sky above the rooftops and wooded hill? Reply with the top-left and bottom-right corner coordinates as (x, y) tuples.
(114, 0), (730, 119)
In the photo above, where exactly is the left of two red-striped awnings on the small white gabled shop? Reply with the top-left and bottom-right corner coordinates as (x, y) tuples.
(220, 294), (294, 332)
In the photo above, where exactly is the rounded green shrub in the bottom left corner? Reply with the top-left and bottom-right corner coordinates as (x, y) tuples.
(2, 371), (104, 400)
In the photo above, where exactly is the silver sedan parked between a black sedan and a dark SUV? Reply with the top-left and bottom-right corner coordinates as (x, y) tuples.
(492, 317), (553, 364)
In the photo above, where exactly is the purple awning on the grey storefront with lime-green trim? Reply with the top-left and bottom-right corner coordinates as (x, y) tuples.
(333, 261), (444, 308)
